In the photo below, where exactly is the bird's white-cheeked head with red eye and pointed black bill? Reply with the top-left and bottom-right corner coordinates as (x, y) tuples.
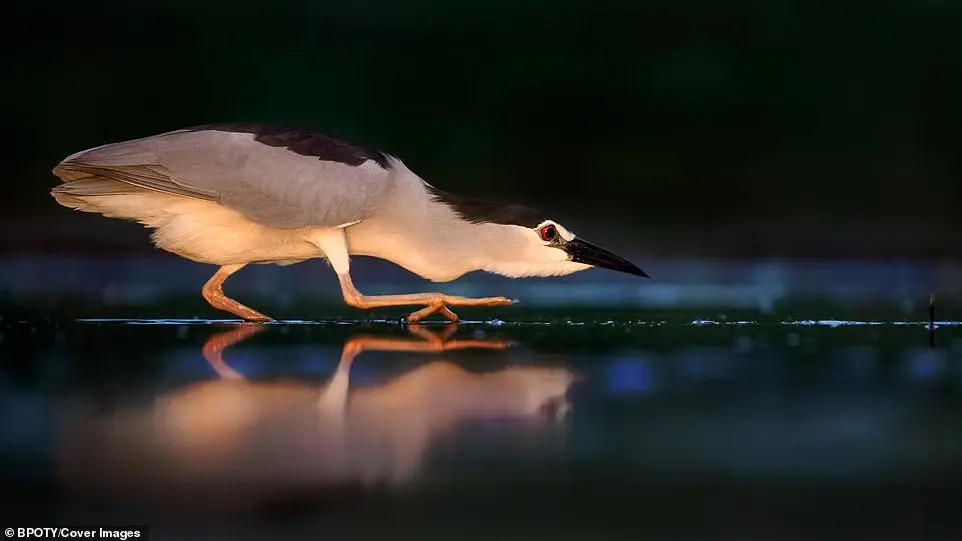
(486, 220), (648, 278)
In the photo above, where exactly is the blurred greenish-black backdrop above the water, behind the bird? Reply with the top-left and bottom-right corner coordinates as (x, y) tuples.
(0, 0), (962, 259)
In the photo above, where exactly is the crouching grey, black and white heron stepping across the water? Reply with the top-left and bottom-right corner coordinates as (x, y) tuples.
(50, 122), (648, 322)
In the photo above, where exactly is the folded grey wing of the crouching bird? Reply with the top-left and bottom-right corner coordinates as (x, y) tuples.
(54, 129), (395, 229)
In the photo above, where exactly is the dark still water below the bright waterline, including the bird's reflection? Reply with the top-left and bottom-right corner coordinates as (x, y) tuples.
(0, 316), (962, 539)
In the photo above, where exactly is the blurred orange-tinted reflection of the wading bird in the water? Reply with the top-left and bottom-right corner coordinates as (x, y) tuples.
(59, 324), (577, 510)
